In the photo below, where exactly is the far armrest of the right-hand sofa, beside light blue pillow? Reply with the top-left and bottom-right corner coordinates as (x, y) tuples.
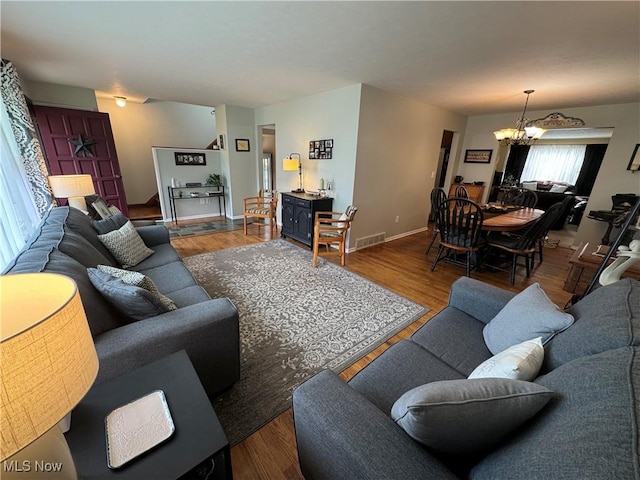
(449, 277), (516, 323)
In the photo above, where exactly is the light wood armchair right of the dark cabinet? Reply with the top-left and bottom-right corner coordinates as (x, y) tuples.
(313, 205), (358, 267)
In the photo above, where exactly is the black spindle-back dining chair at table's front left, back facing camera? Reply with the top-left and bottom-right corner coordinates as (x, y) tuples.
(431, 197), (484, 277)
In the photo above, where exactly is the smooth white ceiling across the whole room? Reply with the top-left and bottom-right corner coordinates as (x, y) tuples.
(1, 0), (640, 115)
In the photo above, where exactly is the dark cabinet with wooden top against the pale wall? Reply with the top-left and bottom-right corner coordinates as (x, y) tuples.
(281, 193), (333, 247)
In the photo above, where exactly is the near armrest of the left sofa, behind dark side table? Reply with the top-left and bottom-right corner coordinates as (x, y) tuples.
(94, 298), (240, 395)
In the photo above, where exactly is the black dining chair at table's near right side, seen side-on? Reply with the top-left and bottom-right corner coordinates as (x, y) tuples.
(487, 203), (562, 285)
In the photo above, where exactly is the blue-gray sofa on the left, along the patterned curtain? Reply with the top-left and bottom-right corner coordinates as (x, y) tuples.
(3, 207), (240, 396)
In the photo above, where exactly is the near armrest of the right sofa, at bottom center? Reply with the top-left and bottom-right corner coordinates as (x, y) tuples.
(293, 370), (457, 480)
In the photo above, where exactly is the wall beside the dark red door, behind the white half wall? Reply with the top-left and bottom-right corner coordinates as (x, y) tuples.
(97, 98), (216, 204)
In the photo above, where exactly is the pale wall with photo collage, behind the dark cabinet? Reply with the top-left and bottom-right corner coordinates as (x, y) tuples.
(254, 84), (361, 222)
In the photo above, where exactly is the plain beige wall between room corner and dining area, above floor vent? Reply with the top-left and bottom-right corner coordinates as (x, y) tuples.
(350, 85), (466, 246)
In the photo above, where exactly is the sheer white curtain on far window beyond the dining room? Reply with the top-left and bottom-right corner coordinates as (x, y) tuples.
(520, 145), (587, 185)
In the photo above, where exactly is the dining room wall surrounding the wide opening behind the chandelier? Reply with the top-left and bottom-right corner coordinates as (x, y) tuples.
(457, 103), (640, 245)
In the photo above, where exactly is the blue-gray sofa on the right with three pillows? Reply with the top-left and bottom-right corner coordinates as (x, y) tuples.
(293, 277), (640, 480)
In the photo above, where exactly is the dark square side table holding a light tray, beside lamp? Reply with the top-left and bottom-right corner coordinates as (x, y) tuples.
(65, 350), (233, 480)
